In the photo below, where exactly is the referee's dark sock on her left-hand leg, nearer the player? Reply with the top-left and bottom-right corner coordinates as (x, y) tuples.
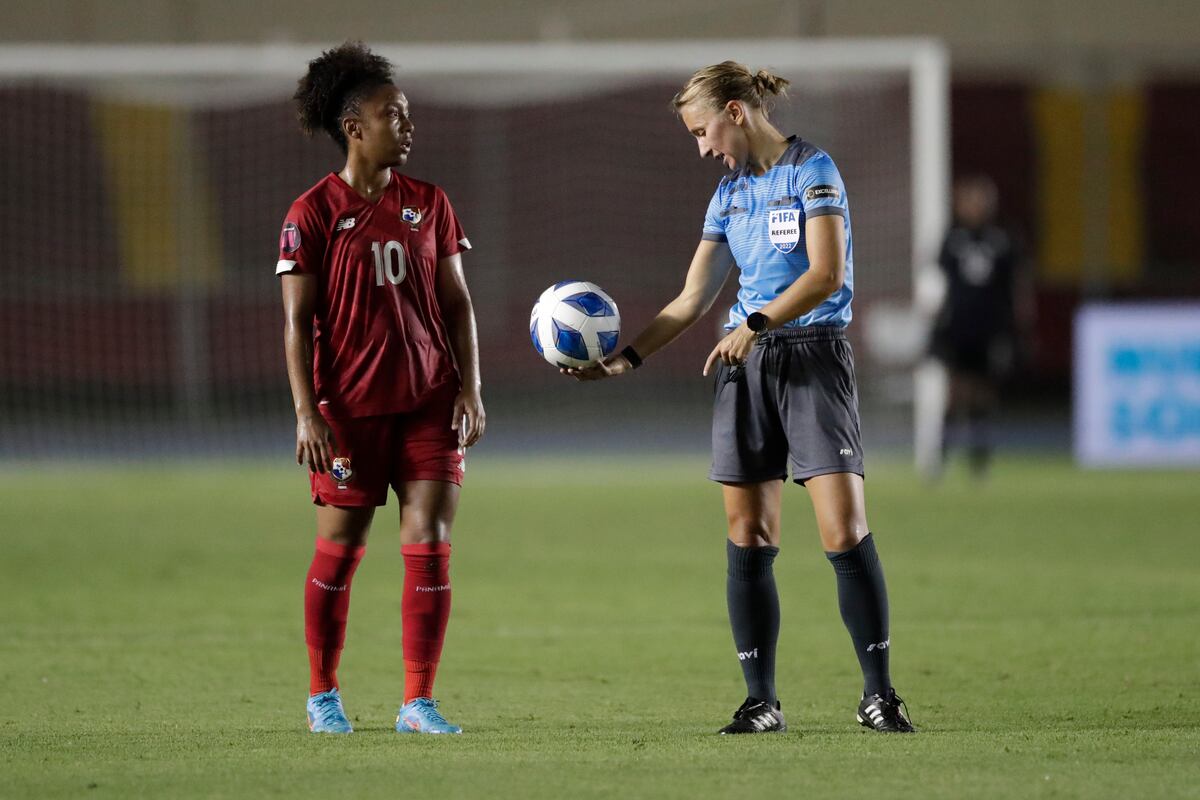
(725, 540), (779, 705)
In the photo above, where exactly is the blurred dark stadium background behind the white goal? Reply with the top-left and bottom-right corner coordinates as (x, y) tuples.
(0, 0), (1200, 458)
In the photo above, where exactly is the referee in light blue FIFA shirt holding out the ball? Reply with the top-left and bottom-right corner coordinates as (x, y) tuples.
(564, 61), (913, 734)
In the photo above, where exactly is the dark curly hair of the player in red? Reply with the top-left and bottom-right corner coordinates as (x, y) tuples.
(292, 42), (392, 152)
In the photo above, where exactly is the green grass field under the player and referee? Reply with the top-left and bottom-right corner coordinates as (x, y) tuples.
(0, 455), (1200, 800)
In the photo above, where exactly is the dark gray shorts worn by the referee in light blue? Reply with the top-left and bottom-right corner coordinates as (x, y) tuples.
(708, 326), (863, 485)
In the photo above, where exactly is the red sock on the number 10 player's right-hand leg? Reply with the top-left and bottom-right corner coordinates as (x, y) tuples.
(400, 542), (450, 703)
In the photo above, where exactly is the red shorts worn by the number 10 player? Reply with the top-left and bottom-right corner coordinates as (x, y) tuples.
(311, 381), (467, 506)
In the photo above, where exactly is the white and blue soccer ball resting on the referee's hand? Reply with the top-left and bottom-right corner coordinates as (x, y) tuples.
(529, 281), (620, 367)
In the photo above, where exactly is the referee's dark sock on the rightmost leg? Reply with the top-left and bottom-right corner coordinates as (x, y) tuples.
(826, 534), (892, 694)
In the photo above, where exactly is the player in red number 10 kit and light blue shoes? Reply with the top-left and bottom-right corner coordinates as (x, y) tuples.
(275, 42), (485, 733)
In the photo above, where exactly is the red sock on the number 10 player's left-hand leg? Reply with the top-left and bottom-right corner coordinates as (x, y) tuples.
(304, 539), (366, 694)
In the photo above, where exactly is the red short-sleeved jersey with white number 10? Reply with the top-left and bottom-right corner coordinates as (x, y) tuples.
(275, 170), (470, 417)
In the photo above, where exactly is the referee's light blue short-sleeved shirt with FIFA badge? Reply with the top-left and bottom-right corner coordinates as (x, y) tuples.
(702, 137), (854, 330)
